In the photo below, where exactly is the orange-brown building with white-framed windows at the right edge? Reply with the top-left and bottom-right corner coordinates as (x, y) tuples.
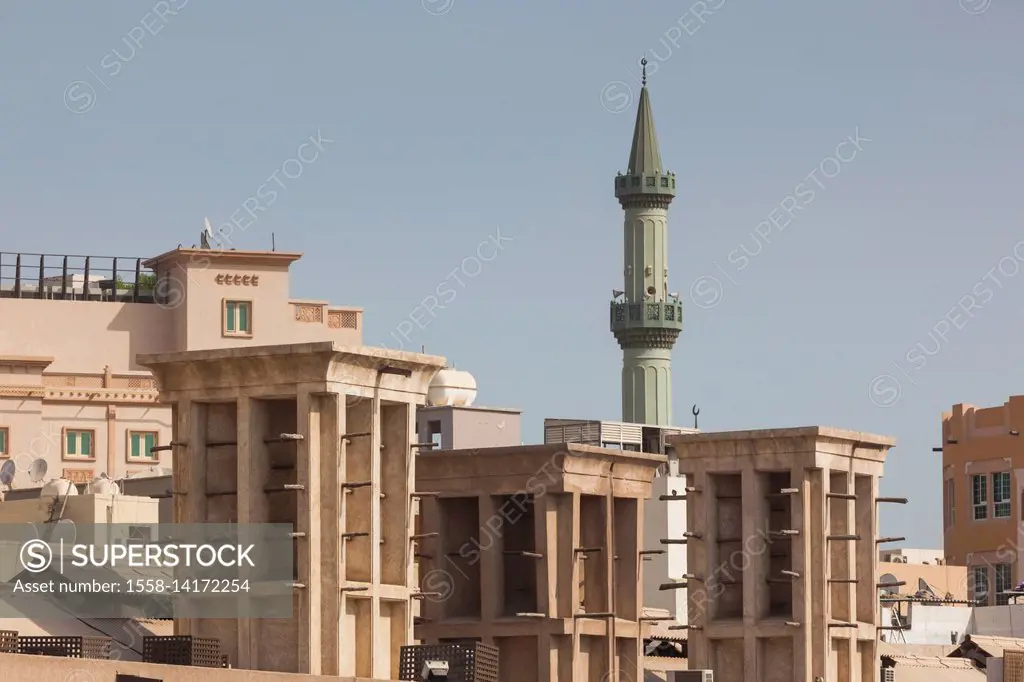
(941, 395), (1024, 606)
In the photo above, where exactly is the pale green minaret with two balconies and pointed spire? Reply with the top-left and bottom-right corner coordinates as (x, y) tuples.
(611, 59), (683, 426)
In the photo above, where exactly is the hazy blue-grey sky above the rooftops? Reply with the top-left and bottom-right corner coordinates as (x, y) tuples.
(0, 0), (1024, 547)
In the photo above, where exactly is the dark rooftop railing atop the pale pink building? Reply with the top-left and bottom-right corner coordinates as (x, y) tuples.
(0, 251), (157, 303)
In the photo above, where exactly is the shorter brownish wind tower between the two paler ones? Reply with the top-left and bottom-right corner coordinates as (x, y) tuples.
(416, 443), (666, 682)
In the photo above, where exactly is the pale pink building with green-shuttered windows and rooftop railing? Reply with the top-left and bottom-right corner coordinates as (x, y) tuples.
(0, 249), (362, 487)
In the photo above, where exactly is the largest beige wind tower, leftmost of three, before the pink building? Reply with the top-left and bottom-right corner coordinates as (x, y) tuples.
(138, 341), (444, 679)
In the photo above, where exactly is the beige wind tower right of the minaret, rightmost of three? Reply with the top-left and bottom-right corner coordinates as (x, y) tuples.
(664, 427), (894, 682)
